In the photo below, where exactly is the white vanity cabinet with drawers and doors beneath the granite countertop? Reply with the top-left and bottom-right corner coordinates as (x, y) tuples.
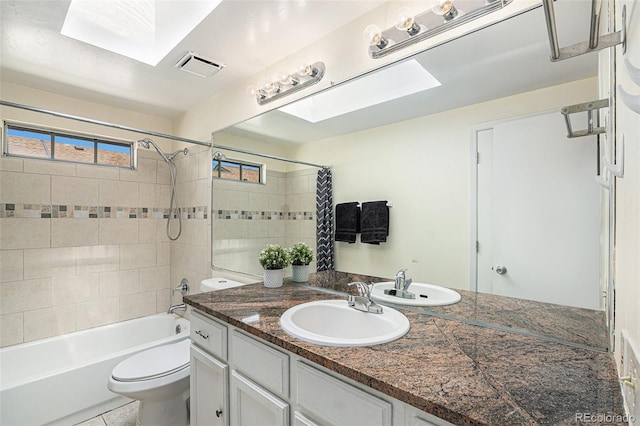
(191, 310), (450, 426)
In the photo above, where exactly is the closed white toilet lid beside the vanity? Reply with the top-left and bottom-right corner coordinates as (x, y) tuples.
(111, 339), (191, 382)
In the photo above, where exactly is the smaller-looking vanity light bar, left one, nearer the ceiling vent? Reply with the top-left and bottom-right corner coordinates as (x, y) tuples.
(247, 62), (326, 105)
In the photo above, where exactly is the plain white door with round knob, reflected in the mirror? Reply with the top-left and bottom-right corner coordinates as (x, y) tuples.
(476, 112), (601, 309)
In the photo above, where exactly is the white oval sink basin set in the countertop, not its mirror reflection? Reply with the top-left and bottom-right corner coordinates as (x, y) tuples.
(280, 300), (409, 346)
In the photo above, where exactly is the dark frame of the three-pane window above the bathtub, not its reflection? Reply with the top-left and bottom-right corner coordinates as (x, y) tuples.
(2, 120), (137, 170)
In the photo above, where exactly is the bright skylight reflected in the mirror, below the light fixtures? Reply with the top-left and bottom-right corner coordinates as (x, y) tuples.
(280, 59), (441, 123)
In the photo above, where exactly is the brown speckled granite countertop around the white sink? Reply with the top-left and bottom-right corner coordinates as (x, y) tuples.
(184, 281), (625, 425)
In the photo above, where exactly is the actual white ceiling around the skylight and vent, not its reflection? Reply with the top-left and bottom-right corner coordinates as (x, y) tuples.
(0, 0), (383, 117)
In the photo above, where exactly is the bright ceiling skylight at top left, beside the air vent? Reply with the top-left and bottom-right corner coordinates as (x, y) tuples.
(60, 0), (222, 66)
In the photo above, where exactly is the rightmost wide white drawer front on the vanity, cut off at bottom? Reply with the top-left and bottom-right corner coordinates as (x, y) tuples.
(296, 362), (392, 426)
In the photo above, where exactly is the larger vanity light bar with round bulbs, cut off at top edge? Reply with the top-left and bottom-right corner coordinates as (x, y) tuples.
(363, 0), (513, 59)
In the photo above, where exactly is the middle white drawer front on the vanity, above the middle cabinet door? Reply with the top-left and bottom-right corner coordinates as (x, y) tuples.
(231, 331), (289, 398)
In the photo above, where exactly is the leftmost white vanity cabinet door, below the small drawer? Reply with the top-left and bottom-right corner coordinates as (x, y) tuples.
(190, 345), (229, 426)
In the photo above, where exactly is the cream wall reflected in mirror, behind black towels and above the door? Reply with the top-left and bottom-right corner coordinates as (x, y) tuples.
(292, 78), (596, 289)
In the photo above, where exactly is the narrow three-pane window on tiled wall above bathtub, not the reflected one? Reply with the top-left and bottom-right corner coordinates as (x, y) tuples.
(4, 123), (133, 168)
